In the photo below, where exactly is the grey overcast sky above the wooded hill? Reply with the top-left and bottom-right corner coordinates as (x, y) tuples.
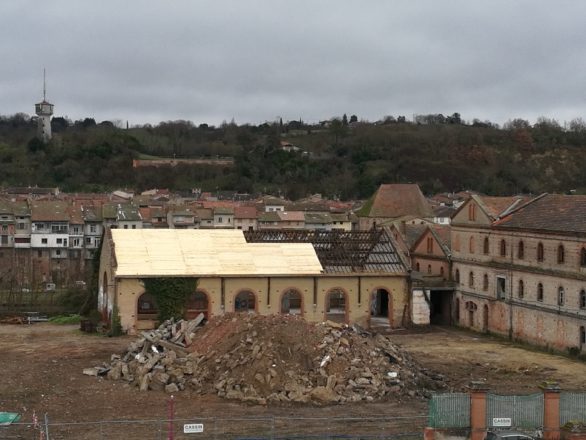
(0, 0), (586, 125)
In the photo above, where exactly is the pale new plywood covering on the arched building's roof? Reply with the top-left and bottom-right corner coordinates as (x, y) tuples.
(112, 229), (322, 277)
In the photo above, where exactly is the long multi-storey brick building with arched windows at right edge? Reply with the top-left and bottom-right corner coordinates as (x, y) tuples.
(452, 194), (586, 351)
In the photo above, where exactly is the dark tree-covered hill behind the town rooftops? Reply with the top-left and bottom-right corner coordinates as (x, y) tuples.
(0, 114), (586, 199)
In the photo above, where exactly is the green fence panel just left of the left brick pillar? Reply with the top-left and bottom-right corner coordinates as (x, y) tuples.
(429, 393), (470, 428)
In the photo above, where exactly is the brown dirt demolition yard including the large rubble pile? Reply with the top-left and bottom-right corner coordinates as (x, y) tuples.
(0, 315), (586, 440)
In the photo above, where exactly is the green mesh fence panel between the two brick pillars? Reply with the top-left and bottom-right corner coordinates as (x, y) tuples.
(486, 393), (543, 429)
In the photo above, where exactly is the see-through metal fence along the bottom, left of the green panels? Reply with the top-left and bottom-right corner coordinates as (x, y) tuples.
(0, 415), (426, 440)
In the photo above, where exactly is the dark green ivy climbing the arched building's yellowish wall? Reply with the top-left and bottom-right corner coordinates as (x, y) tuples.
(141, 277), (197, 322)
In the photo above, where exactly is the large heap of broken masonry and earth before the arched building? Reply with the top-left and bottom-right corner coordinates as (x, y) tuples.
(84, 314), (445, 404)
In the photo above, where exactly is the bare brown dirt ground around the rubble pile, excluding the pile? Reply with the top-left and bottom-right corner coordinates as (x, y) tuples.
(0, 324), (586, 422)
